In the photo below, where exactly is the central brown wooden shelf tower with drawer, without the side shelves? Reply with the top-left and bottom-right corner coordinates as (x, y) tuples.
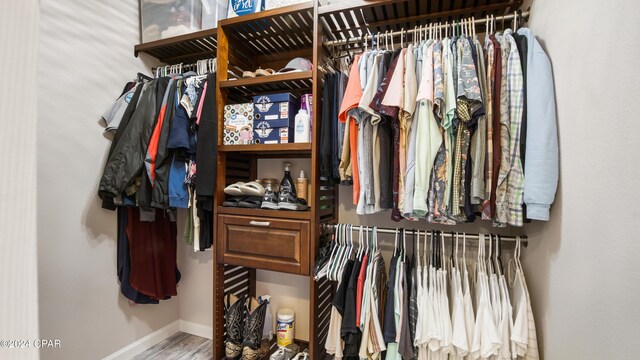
(214, 1), (336, 359)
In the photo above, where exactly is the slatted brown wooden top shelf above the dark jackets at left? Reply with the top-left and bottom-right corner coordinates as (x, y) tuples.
(133, 28), (218, 64)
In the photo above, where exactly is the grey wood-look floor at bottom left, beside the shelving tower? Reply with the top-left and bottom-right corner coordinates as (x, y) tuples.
(133, 332), (213, 360)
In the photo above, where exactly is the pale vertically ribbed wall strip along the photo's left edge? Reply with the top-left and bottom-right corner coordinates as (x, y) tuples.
(0, 0), (39, 359)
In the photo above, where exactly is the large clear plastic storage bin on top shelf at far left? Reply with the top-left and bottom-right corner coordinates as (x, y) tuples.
(139, 0), (202, 43)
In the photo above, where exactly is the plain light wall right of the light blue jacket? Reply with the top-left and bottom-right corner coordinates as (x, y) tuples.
(524, 0), (640, 359)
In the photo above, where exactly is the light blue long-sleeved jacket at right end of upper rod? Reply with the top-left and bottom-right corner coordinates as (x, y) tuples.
(518, 28), (558, 220)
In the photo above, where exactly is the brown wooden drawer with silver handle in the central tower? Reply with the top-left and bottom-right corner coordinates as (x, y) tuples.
(217, 214), (309, 275)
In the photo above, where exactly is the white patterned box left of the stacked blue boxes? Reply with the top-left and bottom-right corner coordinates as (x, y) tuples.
(222, 103), (253, 145)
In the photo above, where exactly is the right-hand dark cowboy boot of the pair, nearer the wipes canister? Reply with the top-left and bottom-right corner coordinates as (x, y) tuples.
(242, 298), (269, 360)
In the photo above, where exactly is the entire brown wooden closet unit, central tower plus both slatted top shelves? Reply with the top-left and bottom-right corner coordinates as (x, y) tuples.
(134, 0), (523, 360)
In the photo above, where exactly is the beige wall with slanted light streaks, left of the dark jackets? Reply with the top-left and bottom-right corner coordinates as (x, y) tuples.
(37, 0), (179, 359)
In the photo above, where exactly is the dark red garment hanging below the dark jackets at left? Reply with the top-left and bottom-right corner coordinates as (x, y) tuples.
(127, 208), (178, 300)
